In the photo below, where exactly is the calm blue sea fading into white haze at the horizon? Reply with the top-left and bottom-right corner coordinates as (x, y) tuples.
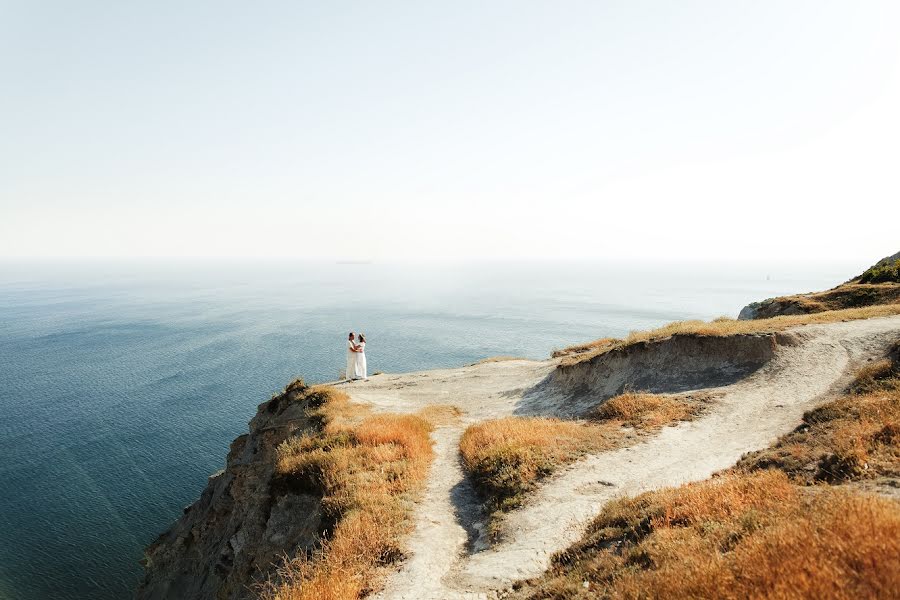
(0, 262), (866, 600)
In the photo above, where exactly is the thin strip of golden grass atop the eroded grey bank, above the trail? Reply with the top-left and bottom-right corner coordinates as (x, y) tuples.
(560, 304), (900, 366)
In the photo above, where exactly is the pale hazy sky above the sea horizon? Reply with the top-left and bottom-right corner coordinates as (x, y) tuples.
(0, 0), (900, 260)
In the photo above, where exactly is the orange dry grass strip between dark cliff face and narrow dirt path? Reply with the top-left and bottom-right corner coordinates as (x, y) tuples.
(261, 388), (433, 600)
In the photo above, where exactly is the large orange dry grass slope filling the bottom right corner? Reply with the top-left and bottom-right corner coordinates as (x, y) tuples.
(518, 472), (900, 599)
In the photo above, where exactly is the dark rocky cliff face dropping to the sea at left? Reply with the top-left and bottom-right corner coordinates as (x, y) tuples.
(135, 383), (327, 599)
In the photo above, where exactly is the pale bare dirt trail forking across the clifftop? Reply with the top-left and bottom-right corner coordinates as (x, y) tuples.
(342, 316), (900, 600)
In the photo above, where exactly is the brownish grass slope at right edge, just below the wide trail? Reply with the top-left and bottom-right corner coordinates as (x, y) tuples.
(735, 350), (900, 484)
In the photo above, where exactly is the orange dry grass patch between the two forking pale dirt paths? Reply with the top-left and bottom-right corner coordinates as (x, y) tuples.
(460, 393), (708, 516)
